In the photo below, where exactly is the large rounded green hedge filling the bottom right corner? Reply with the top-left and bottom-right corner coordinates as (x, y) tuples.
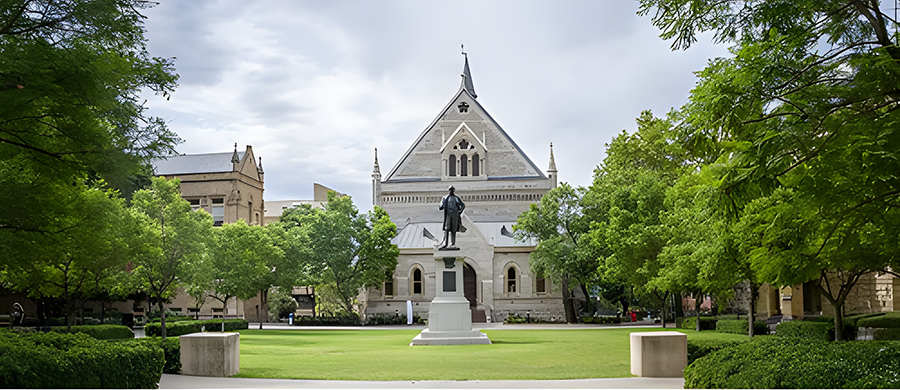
(684, 337), (900, 389)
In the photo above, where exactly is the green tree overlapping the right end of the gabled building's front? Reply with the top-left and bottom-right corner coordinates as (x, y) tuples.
(513, 183), (597, 323)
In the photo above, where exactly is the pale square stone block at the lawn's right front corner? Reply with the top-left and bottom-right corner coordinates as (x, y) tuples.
(631, 332), (687, 378)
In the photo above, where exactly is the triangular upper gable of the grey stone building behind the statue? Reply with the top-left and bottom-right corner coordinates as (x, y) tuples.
(384, 84), (546, 182)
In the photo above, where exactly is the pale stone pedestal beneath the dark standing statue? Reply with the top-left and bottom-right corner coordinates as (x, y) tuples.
(409, 251), (491, 346)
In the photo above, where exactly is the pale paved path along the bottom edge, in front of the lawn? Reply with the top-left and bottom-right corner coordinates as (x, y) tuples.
(159, 374), (684, 389)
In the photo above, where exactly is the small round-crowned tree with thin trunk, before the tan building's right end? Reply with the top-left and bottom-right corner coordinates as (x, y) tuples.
(194, 219), (284, 332)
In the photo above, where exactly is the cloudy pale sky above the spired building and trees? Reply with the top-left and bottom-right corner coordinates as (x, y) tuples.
(145, 0), (727, 210)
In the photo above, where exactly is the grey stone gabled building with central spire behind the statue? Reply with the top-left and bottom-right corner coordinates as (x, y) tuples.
(360, 58), (565, 322)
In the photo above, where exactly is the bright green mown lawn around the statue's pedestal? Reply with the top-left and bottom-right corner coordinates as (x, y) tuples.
(237, 328), (746, 381)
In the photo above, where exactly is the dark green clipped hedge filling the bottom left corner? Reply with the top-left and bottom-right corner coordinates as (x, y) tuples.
(0, 332), (164, 389)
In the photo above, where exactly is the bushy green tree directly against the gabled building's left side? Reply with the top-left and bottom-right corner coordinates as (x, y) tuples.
(281, 192), (400, 314)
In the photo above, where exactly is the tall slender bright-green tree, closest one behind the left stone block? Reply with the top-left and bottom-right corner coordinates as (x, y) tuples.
(131, 177), (213, 338)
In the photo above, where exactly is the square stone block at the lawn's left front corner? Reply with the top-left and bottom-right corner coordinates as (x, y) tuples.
(179, 332), (241, 376)
